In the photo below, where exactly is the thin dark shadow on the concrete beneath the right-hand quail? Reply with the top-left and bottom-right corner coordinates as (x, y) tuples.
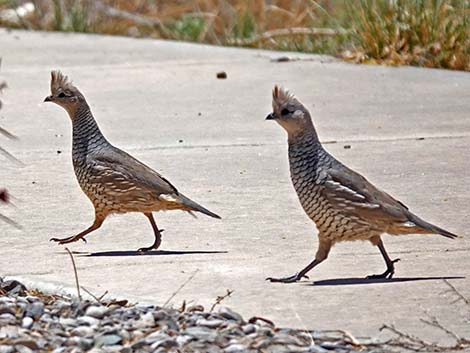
(305, 276), (466, 286)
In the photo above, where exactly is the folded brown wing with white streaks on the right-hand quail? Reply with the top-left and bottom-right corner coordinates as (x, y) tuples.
(322, 165), (410, 224)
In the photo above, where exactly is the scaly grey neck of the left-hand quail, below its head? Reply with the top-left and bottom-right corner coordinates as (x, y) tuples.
(72, 103), (108, 162)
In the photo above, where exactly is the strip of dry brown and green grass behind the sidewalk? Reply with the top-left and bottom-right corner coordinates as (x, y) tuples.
(0, 0), (470, 70)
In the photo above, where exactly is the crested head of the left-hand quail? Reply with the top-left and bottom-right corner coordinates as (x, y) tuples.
(44, 71), (85, 115)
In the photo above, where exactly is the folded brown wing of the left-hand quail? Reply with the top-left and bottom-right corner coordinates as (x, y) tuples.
(89, 147), (179, 195)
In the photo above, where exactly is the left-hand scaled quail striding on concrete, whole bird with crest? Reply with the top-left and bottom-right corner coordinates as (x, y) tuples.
(44, 70), (220, 252)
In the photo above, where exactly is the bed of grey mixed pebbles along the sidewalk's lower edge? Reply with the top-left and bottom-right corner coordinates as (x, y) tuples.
(0, 278), (416, 353)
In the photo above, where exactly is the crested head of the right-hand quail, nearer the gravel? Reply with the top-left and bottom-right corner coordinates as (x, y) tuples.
(266, 86), (313, 135)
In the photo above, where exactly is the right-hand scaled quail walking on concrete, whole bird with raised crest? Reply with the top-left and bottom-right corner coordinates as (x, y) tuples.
(266, 85), (458, 283)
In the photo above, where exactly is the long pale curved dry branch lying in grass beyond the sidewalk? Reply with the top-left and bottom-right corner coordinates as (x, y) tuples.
(229, 27), (348, 45)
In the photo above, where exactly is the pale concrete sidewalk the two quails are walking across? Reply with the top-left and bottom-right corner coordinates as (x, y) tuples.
(0, 30), (470, 341)
